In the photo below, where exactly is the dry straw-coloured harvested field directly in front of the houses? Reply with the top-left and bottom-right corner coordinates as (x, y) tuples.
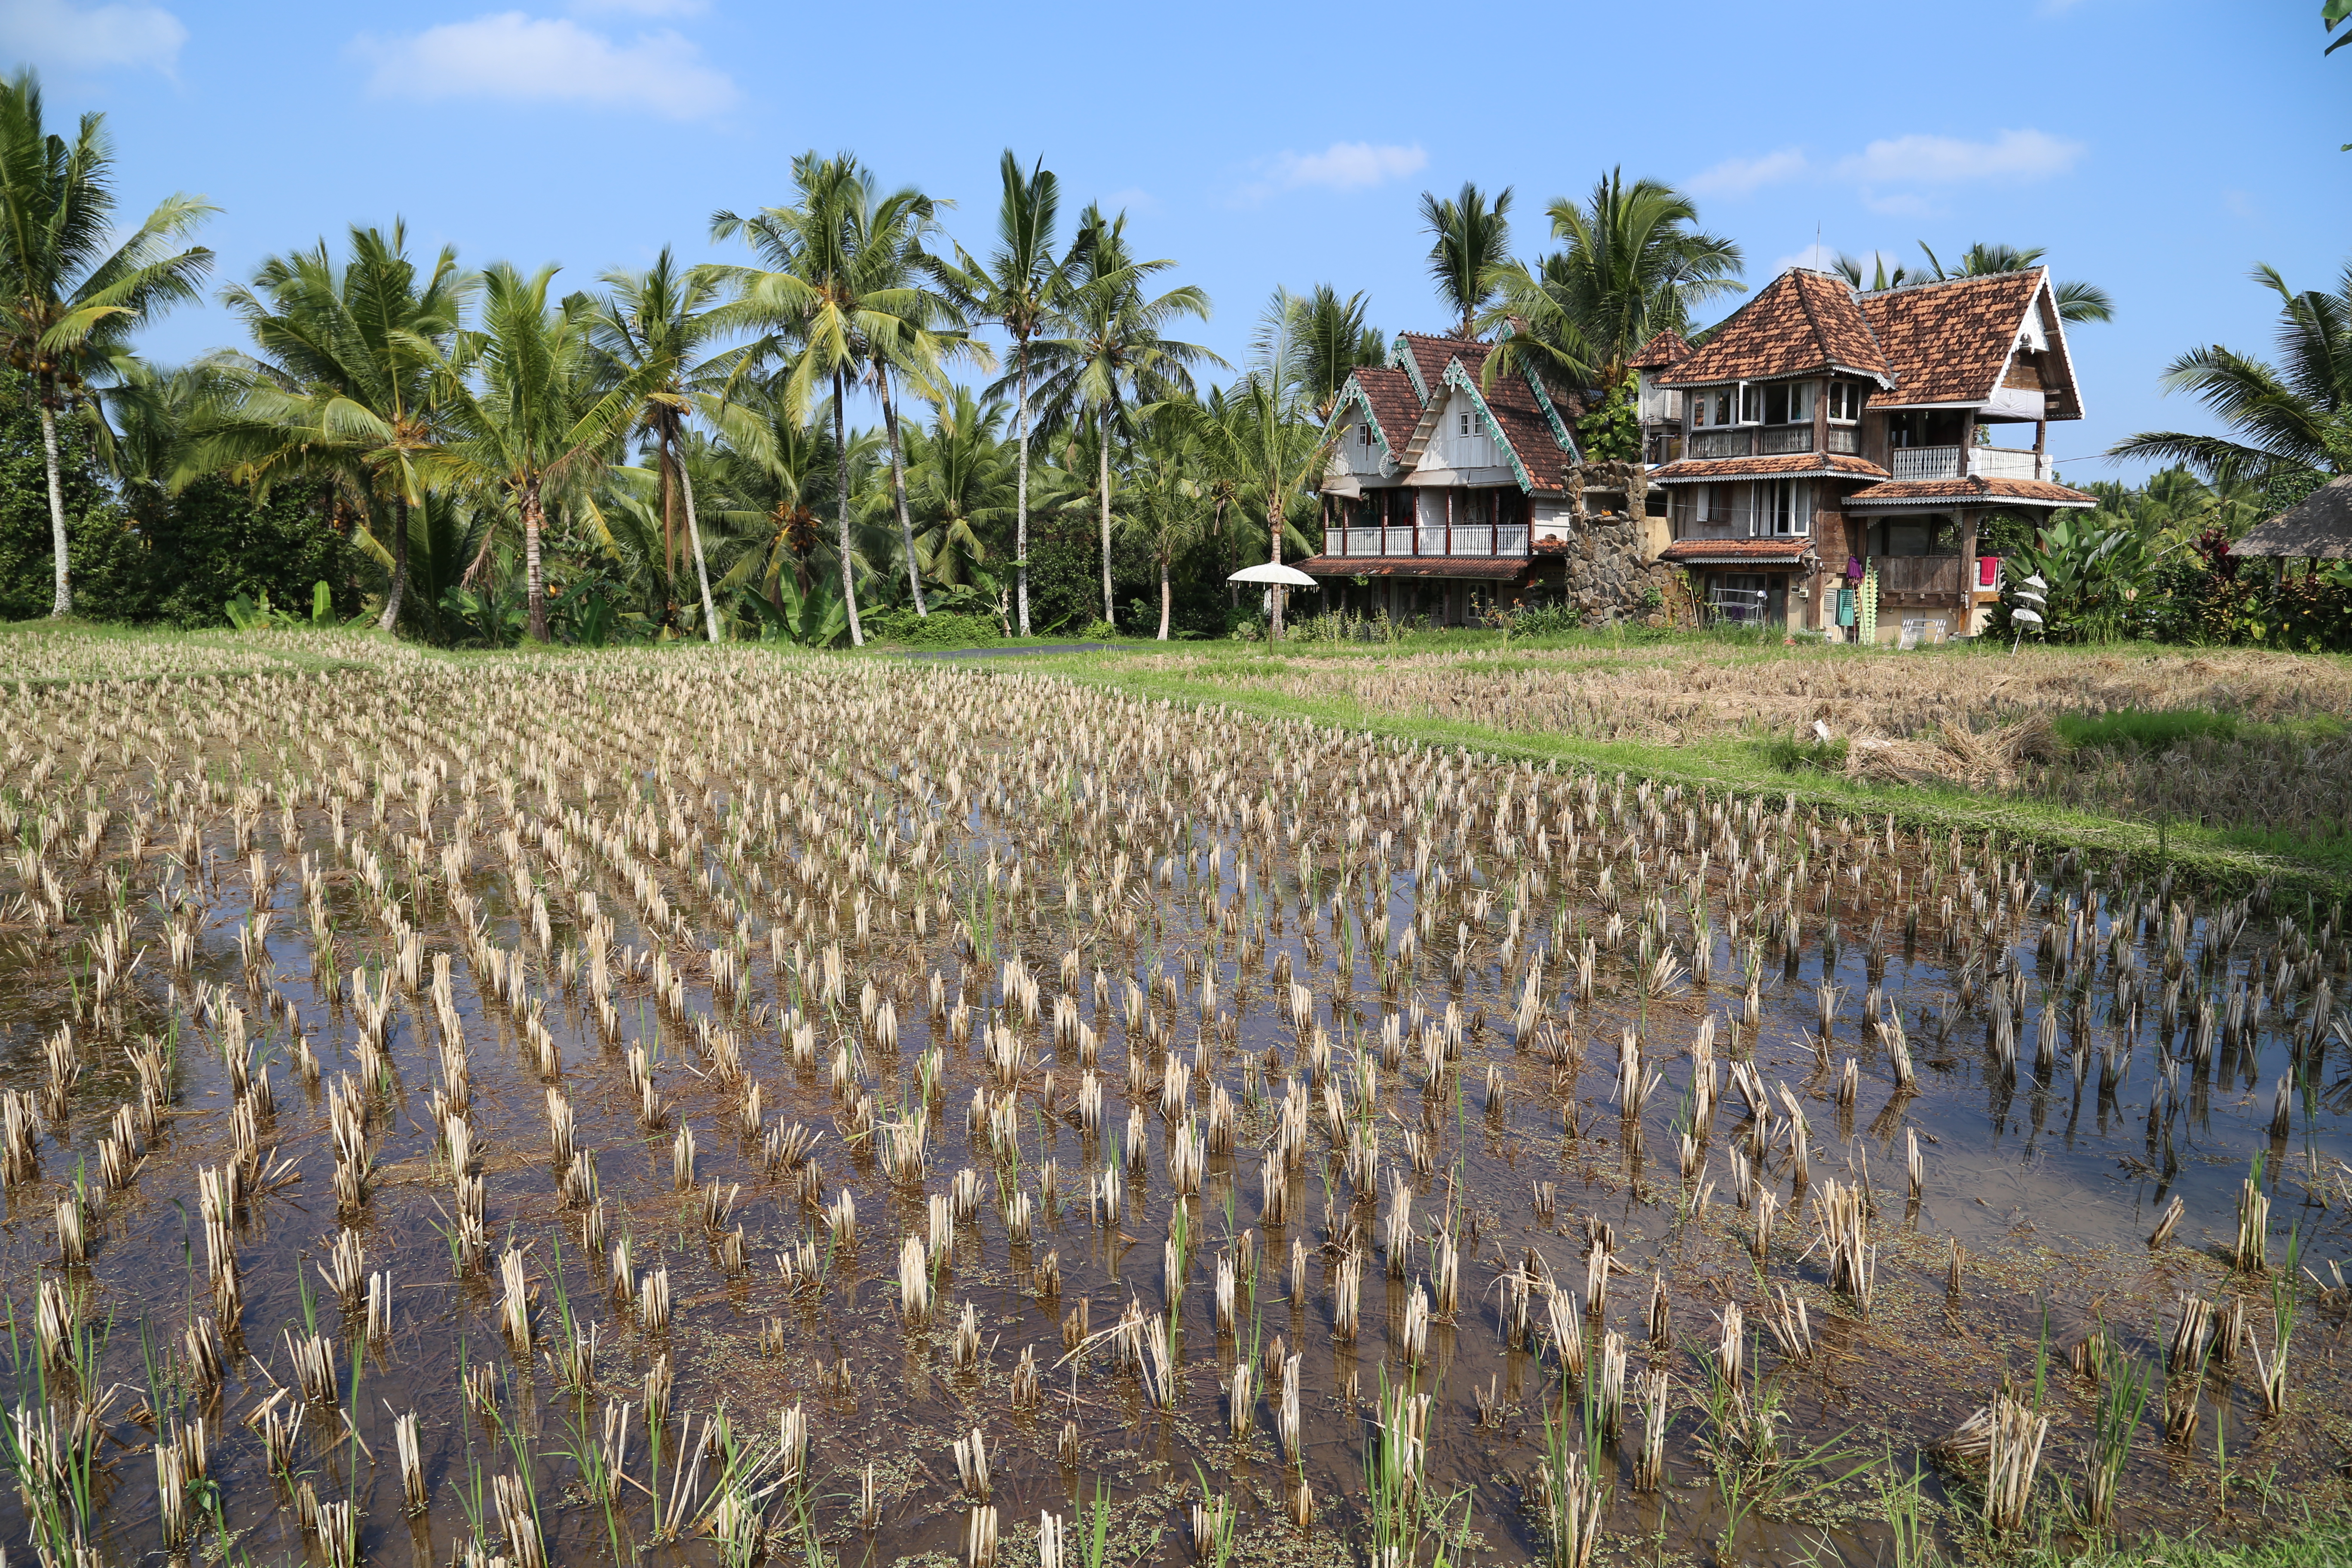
(1131, 640), (2352, 844)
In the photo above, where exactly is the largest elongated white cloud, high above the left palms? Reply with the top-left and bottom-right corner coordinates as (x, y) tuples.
(353, 12), (736, 120)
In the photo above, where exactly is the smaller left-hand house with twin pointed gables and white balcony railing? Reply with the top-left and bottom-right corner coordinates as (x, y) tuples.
(1294, 331), (1656, 625)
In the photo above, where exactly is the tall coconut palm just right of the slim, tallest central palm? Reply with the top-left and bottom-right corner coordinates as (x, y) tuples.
(1037, 205), (1223, 625)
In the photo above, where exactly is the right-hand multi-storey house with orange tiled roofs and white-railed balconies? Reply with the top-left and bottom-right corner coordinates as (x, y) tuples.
(1635, 268), (2096, 642)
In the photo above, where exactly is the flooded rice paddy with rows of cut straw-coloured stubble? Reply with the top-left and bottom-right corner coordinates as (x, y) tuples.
(0, 635), (2352, 1568)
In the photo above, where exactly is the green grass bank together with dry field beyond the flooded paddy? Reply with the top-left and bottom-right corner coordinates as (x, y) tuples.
(969, 632), (2352, 903)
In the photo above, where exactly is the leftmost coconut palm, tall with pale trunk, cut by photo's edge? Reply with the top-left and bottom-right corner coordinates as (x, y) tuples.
(0, 70), (214, 616)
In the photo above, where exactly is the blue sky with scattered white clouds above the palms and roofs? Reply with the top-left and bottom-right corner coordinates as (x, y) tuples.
(0, 0), (2352, 480)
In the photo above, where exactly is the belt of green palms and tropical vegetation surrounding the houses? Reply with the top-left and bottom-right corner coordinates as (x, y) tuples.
(0, 73), (2352, 646)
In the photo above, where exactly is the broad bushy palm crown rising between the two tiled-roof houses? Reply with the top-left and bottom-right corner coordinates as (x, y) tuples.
(1479, 169), (1745, 388)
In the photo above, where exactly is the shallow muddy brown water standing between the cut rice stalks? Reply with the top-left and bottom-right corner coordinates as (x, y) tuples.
(0, 653), (2352, 1563)
